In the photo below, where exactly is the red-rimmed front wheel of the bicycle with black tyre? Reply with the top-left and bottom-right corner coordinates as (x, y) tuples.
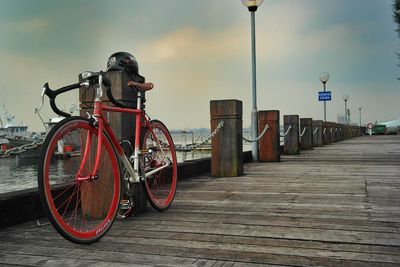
(38, 117), (121, 243)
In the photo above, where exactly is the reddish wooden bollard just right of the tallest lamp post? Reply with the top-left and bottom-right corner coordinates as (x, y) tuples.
(258, 110), (281, 162)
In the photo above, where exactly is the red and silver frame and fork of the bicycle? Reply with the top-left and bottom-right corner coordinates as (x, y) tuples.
(76, 76), (171, 183)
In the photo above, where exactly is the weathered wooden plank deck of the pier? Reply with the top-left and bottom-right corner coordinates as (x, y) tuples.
(0, 136), (400, 266)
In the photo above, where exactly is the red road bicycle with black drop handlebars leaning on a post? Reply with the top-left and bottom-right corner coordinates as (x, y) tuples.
(38, 72), (177, 244)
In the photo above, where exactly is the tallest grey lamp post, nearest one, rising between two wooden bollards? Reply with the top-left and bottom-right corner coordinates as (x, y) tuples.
(242, 0), (264, 161)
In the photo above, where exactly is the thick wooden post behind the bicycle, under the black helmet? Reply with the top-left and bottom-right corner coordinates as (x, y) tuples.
(79, 71), (147, 217)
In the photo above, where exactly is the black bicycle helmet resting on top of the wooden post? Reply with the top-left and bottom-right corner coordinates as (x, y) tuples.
(107, 52), (144, 81)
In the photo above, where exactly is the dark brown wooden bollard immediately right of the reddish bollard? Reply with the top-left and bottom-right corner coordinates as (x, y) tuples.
(283, 115), (300, 155)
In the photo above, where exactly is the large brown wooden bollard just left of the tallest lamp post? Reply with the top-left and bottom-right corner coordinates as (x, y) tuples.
(210, 100), (243, 177)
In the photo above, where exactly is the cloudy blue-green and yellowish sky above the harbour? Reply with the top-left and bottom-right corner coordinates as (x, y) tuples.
(0, 0), (400, 131)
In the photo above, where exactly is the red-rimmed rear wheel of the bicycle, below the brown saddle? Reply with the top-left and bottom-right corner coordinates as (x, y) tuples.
(142, 120), (177, 211)
